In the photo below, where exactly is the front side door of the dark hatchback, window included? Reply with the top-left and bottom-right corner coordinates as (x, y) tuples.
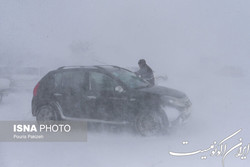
(85, 70), (127, 121)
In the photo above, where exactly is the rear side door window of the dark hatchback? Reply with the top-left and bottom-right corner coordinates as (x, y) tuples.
(61, 71), (87, 92)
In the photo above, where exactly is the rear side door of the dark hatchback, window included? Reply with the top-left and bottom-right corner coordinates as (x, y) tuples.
(54, 70), (88, 118)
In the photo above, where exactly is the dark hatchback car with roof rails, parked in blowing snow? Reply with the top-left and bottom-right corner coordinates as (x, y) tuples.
(32, 66), (191, 135)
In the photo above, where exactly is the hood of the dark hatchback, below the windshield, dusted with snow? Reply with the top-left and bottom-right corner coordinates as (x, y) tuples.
(139, 86), (186, 98)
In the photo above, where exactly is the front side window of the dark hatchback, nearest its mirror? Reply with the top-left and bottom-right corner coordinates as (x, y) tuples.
(89, 71), (118, 92)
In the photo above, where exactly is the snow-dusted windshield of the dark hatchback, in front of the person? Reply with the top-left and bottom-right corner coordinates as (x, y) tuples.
(108, 68), (150, 89)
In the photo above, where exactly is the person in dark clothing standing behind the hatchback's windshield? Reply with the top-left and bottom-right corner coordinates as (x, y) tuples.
(136, 59), (155, 85)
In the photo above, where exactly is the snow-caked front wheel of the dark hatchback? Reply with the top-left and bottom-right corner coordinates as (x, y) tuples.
(135, 112), (168, 136)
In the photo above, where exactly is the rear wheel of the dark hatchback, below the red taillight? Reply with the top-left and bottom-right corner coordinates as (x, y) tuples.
(36, 105), (60, 122)
